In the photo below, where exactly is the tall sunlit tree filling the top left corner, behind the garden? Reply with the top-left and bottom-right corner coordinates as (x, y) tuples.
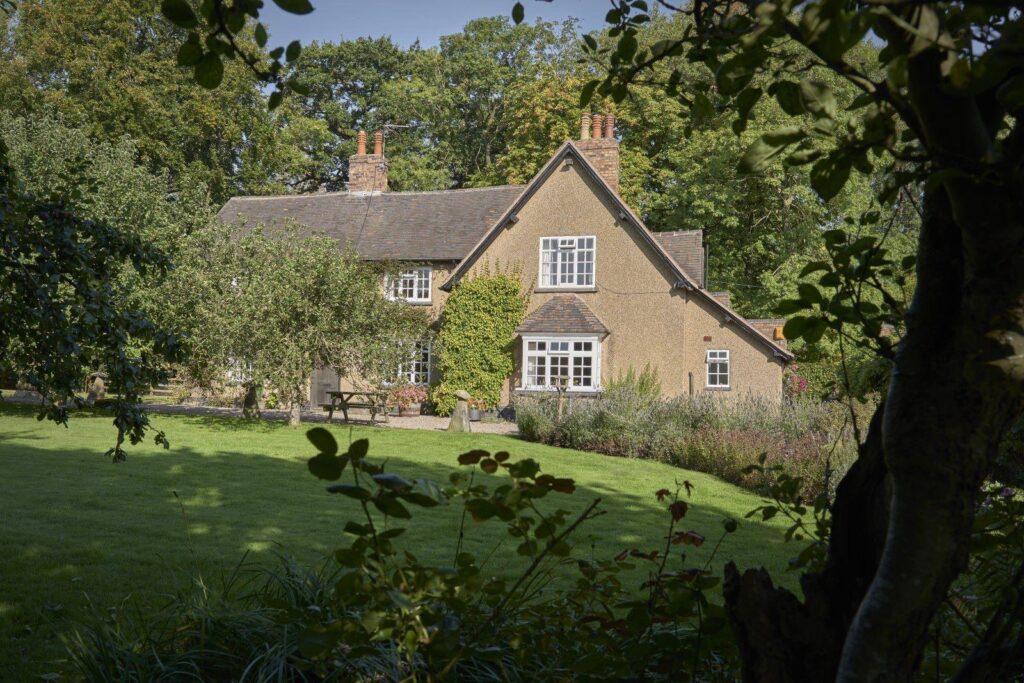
(0, 0), (315, 202)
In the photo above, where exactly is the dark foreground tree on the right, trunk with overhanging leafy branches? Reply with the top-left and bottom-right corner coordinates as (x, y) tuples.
(569, 0), (1024, 681)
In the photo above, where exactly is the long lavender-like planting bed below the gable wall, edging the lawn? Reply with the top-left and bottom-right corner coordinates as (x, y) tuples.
(515, 369), (856, 499)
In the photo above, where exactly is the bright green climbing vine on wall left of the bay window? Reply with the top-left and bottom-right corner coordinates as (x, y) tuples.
(431, 266), (527, 415)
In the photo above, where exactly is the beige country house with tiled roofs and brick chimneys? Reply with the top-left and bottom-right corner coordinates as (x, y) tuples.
(219, 114), (793, 411)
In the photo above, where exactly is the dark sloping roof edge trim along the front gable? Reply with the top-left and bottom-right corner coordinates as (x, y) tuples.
(441, 141), (794, 361)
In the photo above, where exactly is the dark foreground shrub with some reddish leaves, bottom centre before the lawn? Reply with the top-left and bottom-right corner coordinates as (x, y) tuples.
(298, 428), (737, 680)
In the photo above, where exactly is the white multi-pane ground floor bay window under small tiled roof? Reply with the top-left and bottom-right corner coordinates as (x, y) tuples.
(522, 337), (601, 391)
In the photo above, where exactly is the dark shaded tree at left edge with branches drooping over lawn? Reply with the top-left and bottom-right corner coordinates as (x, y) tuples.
(0, 139), (179, 461)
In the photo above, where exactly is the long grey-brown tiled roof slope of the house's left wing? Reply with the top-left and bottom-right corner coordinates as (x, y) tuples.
(217, 185), (522, 261)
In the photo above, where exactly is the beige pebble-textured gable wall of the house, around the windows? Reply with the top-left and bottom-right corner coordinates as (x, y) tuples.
(456, 158), (782, 399)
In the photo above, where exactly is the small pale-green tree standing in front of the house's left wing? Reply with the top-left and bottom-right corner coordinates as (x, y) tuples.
(163, 226), (427, 425)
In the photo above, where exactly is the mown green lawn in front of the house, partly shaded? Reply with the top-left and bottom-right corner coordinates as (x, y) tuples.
(0, 405), (797, 680)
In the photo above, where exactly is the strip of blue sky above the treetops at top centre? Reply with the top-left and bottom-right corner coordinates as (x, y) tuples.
(260, 0), (610, 46)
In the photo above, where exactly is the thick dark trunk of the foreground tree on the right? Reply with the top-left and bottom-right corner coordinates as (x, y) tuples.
(724, 179), (1024, 681)
